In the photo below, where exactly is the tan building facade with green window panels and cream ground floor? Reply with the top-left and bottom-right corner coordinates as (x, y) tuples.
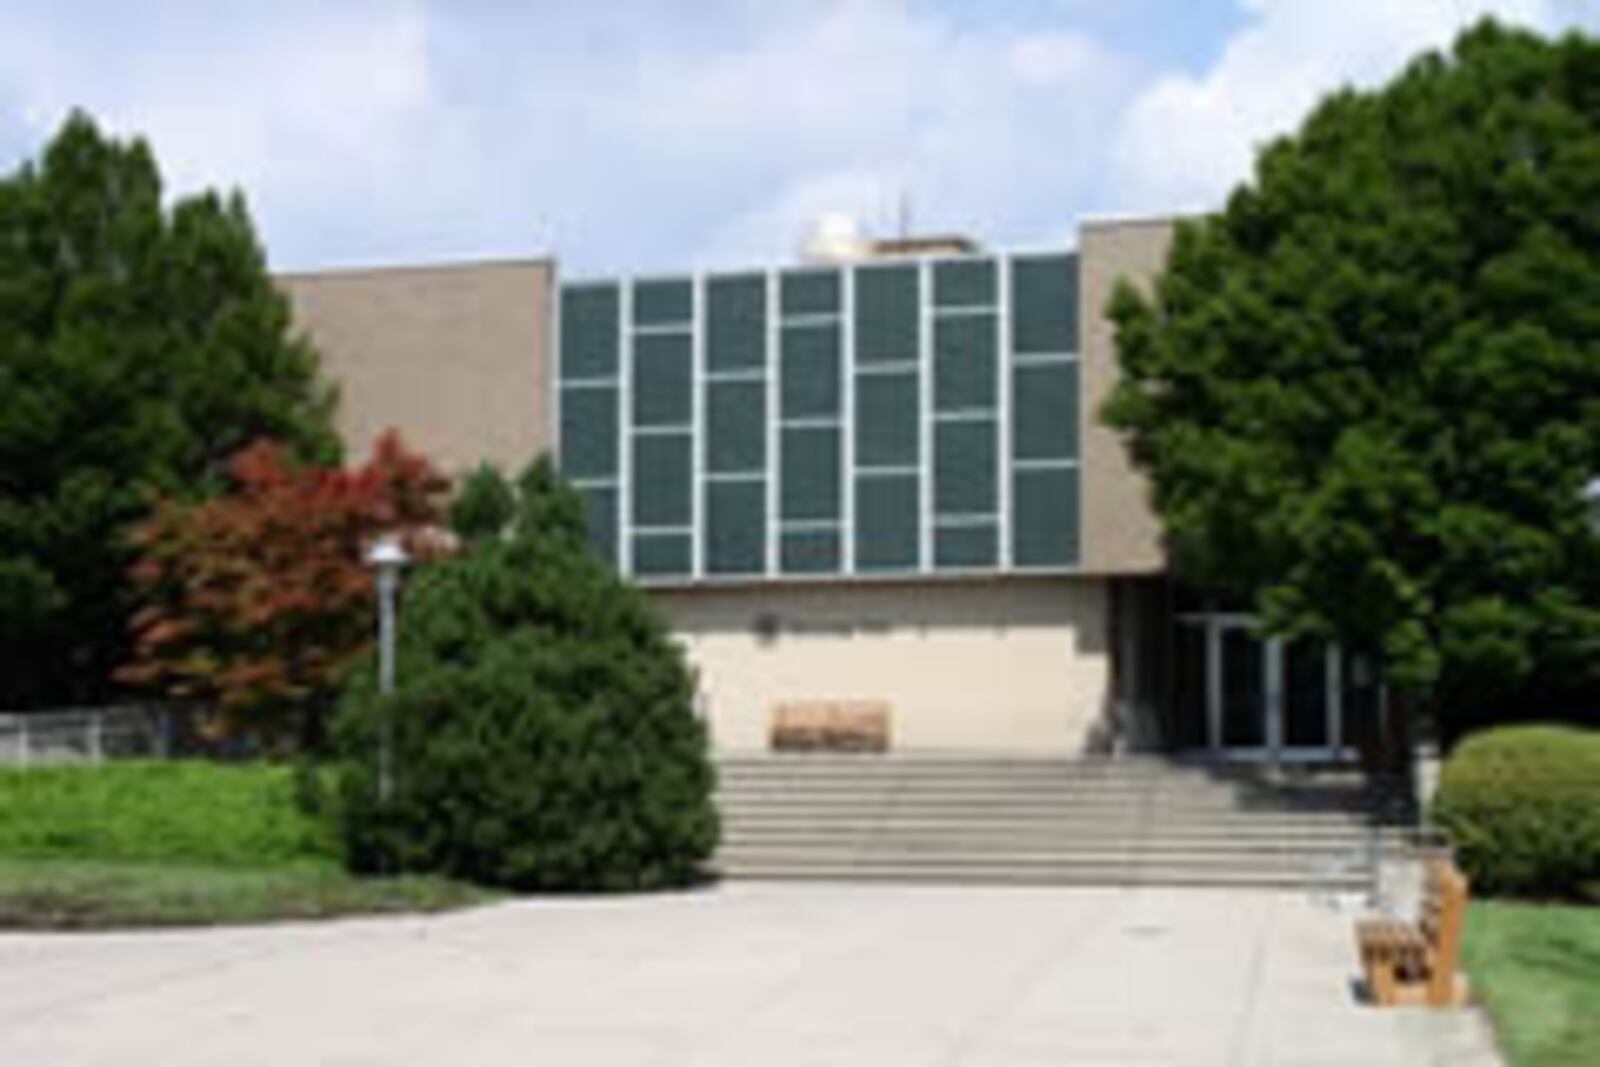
(283, 221), (1376, 758)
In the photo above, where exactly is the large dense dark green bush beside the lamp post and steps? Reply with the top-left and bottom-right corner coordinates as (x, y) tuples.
(336, 461), (717, 891)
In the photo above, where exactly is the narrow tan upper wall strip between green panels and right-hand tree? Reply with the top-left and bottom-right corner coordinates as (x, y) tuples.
(1078, 219), (1173, 574)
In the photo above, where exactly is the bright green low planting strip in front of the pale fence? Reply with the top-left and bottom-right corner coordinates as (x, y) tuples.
(0, 761), (339, 867)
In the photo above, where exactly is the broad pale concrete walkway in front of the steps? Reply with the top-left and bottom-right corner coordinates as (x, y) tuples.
(0, 885), (1498, 1067)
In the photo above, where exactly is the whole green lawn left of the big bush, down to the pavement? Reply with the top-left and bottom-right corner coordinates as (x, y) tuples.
(0, 761), (490, 929)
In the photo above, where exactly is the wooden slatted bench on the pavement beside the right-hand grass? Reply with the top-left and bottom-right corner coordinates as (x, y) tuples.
(1355, 857), (1467, 1008)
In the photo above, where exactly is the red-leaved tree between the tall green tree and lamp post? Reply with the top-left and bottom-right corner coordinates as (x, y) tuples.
(118, 430), (450, 745)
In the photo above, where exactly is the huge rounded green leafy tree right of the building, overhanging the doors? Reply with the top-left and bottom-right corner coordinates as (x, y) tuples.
(1107, 22), (1600, 742)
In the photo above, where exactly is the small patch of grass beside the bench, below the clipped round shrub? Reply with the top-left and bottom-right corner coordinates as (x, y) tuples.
(1464, 901), (1600, 1067)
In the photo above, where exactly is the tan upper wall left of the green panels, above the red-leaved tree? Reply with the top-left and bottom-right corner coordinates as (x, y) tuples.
(278, 261), (554, 474)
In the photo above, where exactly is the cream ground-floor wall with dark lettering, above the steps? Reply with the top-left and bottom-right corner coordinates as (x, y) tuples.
(650, 577), (1110, 755)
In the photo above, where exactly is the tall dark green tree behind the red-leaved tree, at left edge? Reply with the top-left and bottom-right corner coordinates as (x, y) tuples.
(0, 115), (338, 709)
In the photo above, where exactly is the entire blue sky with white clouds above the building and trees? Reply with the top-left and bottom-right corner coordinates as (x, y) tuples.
(0, 0), (1600, 274)
